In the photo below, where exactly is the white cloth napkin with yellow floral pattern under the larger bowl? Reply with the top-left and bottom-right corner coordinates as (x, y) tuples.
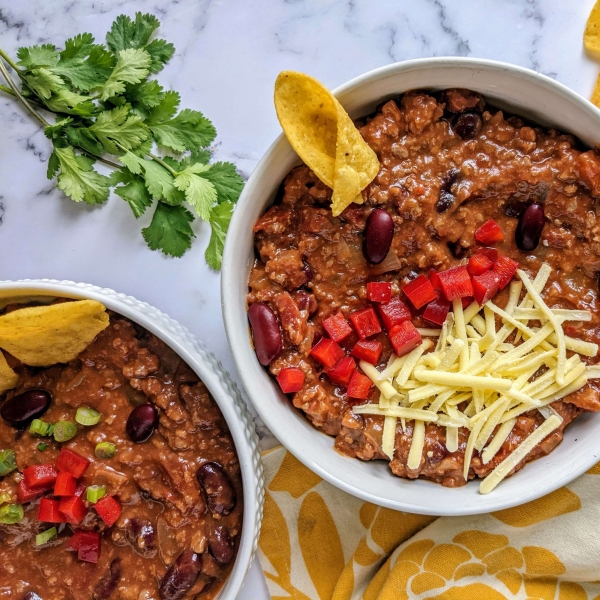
(259, 447), (600, 600)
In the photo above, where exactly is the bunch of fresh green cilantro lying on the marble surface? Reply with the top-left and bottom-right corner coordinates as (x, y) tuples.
(0, 13), (243, 270)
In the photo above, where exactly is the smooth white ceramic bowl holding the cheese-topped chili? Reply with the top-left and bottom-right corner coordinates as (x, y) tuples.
(221, 58), (600, 515)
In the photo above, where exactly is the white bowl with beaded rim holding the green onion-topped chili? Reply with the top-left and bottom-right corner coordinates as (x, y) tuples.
(0, 279), (264, 600)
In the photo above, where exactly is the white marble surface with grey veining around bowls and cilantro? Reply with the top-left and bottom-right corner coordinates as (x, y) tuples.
(0, 0), (600, 600)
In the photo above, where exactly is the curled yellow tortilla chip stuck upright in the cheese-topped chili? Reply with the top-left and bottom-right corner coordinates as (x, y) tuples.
(275, 71), (379, 217)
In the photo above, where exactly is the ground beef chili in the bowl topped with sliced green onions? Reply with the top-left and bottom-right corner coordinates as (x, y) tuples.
(0, 307), (242, 600)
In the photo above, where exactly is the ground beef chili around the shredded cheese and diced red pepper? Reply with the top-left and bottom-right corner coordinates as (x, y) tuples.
(248, 89), (600, 487)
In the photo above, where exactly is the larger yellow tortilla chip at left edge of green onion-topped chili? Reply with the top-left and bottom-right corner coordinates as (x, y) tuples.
(0, 300), (109, 367)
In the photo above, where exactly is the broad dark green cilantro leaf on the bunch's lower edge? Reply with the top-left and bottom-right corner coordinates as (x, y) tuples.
(142, 202), (195, 256)
